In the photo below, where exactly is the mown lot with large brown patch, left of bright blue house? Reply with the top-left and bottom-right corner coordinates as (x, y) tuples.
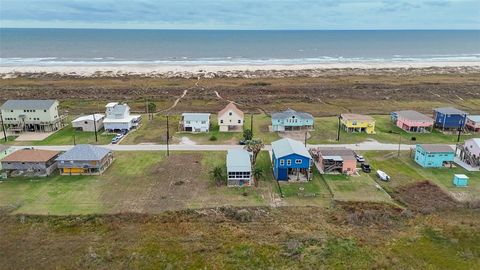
(0, 152), (275, 215)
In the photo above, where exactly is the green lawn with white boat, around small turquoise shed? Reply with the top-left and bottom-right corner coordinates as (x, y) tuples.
(365, 152), (480, 201)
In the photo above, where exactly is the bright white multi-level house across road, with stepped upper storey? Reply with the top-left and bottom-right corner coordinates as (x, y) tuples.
(103, 102), (142, 132)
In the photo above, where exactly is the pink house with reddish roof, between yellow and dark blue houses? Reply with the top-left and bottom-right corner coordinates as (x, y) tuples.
(391, 110), (434, 133)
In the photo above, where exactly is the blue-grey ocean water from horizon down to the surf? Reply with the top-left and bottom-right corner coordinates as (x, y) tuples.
(0, 29), (480, 66)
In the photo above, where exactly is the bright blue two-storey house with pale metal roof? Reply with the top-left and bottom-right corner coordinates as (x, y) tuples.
(272, 138), (312, 181)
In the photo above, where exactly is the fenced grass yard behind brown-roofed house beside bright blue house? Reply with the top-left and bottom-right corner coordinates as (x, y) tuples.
(323, 173), (393, 203)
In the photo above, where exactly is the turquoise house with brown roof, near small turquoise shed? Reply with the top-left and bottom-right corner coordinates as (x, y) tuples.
(415, 144), (455, 168)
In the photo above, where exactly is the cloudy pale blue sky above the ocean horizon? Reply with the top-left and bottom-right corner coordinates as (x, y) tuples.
(0, 0), (480, 29)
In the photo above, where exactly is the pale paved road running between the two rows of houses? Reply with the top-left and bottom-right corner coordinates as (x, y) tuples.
(9, 142), (432, 151)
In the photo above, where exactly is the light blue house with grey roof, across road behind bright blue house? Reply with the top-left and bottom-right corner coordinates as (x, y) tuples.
(272, 109), (315, 131)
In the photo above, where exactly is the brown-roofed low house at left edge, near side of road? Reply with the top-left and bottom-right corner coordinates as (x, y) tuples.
(1, 149), (60, 176)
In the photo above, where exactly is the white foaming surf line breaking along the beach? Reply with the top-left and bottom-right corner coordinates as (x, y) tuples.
(0, 54), (480, 67)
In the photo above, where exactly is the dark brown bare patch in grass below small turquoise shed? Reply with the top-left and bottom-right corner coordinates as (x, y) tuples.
(393, 181), (461, 214)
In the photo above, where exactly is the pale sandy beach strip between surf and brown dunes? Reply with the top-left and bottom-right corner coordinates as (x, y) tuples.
(0, 61), (480, 79)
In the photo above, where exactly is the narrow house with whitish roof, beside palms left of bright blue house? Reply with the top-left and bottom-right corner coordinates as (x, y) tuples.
(227, 149), (253, 187)
